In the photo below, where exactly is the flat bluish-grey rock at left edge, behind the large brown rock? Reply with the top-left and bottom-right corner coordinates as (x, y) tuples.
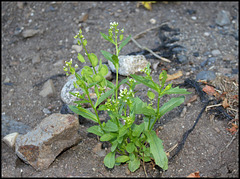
(1, 114), (31, 136)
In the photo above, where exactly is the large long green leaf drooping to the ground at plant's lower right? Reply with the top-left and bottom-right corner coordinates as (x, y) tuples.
(145, 130), (168, 170)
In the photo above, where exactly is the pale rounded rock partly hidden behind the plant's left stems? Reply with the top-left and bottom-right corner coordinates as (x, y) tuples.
(61, 64), (112, 105)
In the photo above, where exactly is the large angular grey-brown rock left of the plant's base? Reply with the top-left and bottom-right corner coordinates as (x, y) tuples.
(15, 113), (81, 170)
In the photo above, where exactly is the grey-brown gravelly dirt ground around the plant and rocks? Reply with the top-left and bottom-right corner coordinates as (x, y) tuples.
(1, 1), (239, 177)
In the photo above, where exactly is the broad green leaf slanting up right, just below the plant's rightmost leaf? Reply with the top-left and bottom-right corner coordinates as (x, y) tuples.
(158, 96), (185, 118)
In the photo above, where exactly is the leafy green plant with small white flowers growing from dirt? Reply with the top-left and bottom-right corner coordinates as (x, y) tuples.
(64, 22), (189, 172)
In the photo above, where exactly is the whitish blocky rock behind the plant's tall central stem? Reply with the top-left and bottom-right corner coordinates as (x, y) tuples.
(108, 55), (150, 76)
